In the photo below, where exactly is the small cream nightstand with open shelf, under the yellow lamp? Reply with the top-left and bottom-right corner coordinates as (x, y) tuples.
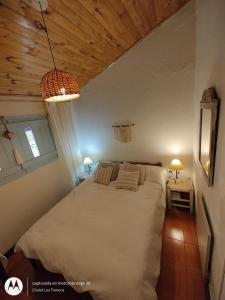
(167, 179), (194, 213)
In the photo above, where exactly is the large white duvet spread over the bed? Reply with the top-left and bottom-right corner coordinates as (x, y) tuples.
(16, 179), (165, 300)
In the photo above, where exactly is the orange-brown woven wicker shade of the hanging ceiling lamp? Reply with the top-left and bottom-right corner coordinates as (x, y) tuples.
(41, 69), (80, 102)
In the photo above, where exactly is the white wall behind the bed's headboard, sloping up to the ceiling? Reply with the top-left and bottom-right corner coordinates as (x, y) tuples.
(75, 3), (195, 175)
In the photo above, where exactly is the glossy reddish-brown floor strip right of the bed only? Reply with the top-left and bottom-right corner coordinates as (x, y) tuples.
(157, 209), (206, 300)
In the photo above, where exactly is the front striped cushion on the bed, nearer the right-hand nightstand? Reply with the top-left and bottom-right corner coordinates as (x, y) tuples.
(116, 170), (140, 192)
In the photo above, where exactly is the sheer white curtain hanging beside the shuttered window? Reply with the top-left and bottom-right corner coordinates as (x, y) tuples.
(47, 102), (82, 187)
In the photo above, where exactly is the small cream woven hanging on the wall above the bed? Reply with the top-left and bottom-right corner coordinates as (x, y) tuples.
(112, 122), (134, 143)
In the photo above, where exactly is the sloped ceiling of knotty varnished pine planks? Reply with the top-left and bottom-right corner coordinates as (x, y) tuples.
(0, 0), (189, 101)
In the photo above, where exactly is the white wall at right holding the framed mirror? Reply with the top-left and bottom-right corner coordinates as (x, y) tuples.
(194, 0), (225, 300)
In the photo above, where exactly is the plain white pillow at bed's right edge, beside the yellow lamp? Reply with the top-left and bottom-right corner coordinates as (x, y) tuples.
(145, 166), (168, 186)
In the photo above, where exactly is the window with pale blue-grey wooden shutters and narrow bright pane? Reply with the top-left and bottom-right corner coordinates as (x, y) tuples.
(0, 115), (57, 185)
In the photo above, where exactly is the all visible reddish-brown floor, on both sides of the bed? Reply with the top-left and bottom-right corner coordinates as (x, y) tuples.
(0, 210), (206, 300)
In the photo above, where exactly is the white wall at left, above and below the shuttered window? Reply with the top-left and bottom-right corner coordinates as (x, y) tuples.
(0, 102), (69, 253)
